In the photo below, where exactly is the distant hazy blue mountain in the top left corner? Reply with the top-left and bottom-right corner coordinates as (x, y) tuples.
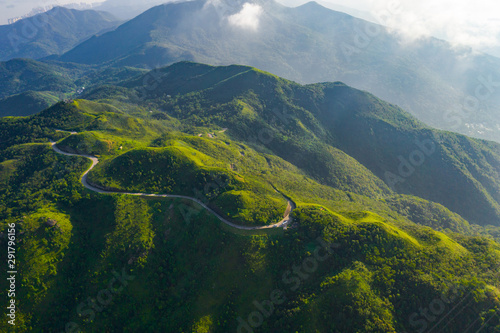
(0, 7), (119, 61)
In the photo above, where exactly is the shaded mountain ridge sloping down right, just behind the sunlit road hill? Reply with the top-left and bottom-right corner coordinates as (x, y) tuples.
(103, 63), (500, 225)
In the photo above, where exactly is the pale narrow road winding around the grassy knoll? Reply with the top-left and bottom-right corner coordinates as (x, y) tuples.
(50, 141), (296, 230)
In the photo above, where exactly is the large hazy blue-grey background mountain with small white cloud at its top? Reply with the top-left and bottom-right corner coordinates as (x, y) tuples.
(60, 0), (500, 141)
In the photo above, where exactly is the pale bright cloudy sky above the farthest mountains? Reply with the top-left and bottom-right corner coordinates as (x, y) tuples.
(0, 0), (500, 56)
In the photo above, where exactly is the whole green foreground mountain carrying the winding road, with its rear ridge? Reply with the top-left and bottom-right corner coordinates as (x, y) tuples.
(0, 62), (500, 333)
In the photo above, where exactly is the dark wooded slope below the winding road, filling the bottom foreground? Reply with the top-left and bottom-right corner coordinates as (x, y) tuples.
(0, 158), (499, 332)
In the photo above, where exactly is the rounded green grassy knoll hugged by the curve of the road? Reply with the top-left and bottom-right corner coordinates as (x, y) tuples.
(89, 142), (286, 225)
